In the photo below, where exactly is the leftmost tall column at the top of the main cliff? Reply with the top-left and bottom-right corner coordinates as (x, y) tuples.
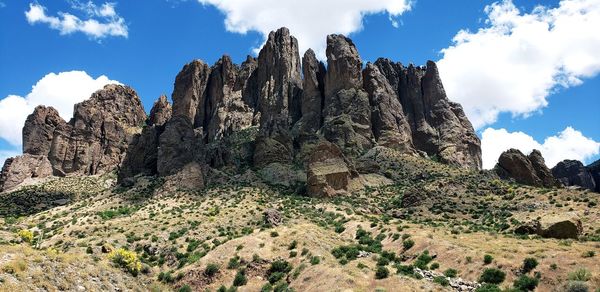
(172, 60), (210, 128)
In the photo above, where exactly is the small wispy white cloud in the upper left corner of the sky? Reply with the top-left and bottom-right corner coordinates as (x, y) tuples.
(25, 1), (128, 40)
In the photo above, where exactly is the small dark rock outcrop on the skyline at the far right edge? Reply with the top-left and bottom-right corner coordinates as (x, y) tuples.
(552, 159), (596, 191)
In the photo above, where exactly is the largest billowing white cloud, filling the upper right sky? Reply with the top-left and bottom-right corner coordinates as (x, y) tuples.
(438, 0), (600, 128)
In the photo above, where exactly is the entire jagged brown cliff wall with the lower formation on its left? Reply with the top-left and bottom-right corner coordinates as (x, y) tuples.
(0, 28), (481, 192)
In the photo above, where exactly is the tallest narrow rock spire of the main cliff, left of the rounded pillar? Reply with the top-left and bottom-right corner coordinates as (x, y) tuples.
(254, 28), (302, 166)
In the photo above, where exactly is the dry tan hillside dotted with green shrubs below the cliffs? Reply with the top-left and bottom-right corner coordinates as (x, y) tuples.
(0, 151), (600, 291)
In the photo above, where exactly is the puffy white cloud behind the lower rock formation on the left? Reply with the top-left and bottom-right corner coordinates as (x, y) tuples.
(0, 71), (119, 146)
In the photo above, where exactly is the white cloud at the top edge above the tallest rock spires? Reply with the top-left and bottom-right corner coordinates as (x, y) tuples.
(198, 0), (412, 59)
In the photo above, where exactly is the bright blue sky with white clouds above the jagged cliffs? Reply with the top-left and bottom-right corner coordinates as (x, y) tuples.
(0, 0), (600, 166)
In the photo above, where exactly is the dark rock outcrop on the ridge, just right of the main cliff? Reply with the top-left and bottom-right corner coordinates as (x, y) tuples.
(494, 149), (559, 187)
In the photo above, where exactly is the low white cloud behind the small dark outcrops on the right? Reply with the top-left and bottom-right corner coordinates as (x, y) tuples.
(481, 127), (600, 169)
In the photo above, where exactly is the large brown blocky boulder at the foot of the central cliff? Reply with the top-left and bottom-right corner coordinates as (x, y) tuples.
(307, 141), (351, 197)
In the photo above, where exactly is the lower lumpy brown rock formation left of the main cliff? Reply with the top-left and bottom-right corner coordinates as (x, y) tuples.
(0, 84), (146, 190)
